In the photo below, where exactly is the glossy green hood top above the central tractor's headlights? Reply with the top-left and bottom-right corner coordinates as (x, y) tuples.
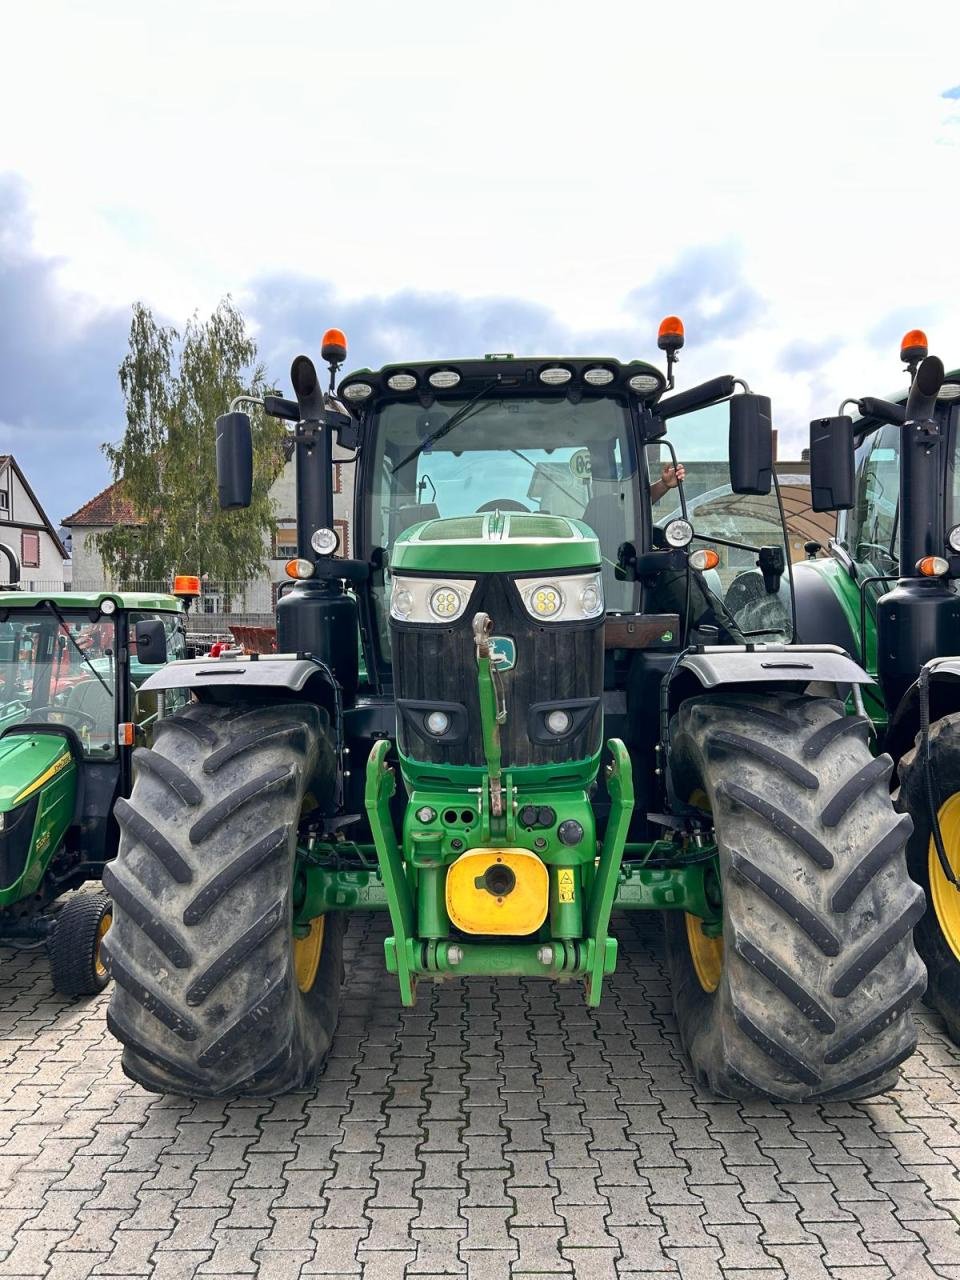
(390, 511), (600, 573)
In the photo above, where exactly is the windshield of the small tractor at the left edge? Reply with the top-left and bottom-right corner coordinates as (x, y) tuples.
(0, 609), (116, 760)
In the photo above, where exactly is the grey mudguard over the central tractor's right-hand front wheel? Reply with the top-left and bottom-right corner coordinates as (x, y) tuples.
(680, 644), (874, 689)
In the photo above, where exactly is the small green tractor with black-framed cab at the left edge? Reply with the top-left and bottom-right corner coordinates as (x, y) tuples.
(0, 570), (192, 996)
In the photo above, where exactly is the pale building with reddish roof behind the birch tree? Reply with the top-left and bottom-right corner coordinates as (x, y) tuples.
(63, 445), (353, 631)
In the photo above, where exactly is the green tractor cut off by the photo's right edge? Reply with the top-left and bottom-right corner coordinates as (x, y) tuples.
(796, 330), (960, 1043)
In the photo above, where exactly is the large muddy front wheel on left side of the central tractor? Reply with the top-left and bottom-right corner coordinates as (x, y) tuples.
(104, 704), (343, 1097)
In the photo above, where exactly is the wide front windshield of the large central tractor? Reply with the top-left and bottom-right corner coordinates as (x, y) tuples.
(367, 394), (637, 650)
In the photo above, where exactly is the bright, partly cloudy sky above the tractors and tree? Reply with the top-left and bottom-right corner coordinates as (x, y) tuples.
(0, 0), (960, 522)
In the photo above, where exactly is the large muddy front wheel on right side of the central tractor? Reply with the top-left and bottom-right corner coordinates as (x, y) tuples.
(666, 694), (925, 1102)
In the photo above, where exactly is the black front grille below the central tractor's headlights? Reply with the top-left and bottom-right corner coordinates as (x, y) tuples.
(392, 575), (603, 768)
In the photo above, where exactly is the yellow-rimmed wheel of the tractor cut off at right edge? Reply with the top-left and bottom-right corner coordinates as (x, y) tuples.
(897, 716), (960, 1044)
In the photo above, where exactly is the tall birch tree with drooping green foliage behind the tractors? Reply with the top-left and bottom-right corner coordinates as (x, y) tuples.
(97, 298), (284, 582)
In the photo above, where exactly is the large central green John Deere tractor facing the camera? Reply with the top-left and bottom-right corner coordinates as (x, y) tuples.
(105, 319), (924, 1101)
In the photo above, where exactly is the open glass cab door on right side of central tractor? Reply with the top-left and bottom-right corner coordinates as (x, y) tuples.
(645, 403), (796, 643)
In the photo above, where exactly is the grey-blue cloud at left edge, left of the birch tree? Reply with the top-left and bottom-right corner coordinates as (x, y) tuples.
(0, 175), (129, 524)
